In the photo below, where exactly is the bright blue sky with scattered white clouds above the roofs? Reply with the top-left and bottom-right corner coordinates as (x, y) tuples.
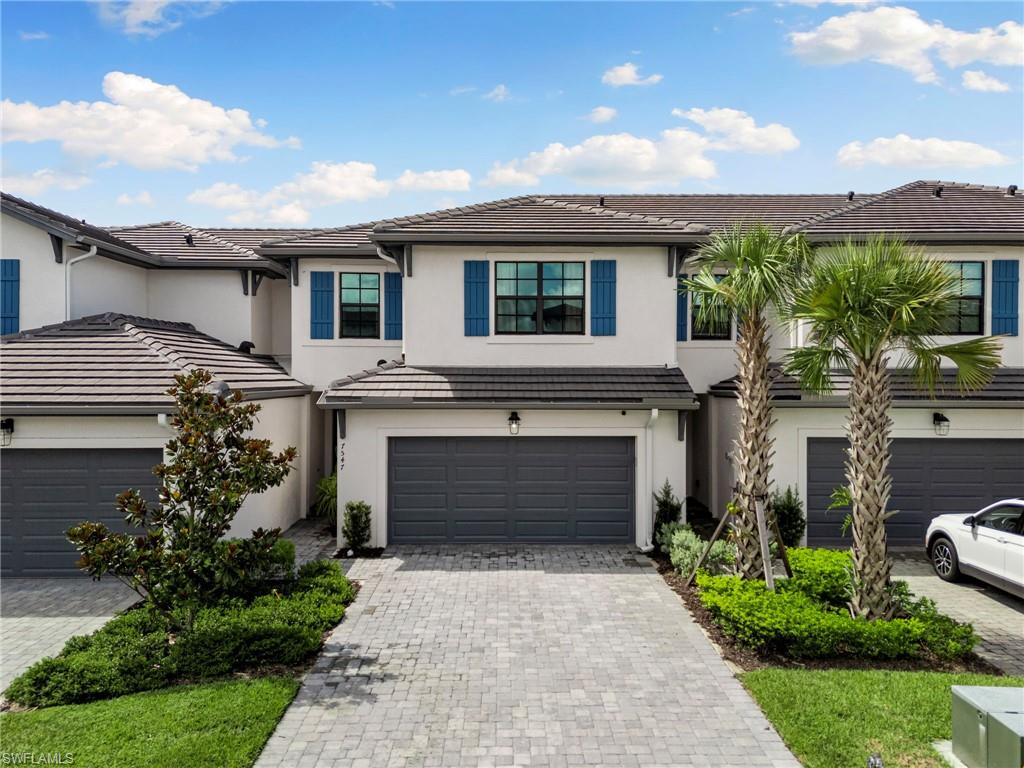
(0, 0), (1024, 226)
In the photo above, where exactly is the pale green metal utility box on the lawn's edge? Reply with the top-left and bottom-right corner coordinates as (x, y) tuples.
(952, 685), (1024, 768)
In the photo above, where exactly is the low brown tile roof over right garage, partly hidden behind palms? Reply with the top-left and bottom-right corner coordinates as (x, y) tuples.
(709, 365), (1024, 407)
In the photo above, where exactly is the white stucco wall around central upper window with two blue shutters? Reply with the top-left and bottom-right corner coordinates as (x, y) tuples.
(404, 246), (676, 366)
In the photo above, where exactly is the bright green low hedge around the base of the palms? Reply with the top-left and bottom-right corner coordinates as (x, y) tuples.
(697, 573), (976, 658)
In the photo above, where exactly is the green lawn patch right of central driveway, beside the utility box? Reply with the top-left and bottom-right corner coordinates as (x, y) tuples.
(740, 669), (1024, 768)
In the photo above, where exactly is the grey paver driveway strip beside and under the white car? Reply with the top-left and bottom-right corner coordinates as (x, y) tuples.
(893, 555), (1024, 675)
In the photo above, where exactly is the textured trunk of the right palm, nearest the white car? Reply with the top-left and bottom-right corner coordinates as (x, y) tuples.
(846, 354), (892, 620)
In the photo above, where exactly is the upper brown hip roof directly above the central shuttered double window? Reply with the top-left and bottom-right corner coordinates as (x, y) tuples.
(371, 196), (710, 244)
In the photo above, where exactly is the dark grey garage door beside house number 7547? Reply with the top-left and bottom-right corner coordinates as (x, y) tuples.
(388, 437), (634, 544)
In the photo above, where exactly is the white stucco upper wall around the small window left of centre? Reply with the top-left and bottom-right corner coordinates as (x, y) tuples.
(291, 259), (401, 390)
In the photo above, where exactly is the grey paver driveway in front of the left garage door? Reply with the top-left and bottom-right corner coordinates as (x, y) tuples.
(0, 579), (139, 690)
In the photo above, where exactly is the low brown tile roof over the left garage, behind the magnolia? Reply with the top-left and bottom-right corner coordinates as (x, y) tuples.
(0, 313), (309, 414)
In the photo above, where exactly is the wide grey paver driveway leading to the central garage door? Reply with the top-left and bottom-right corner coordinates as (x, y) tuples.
(257, 547), (799, 768)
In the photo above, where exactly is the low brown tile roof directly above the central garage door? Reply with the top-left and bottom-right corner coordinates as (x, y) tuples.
(319, 362), (695, 408)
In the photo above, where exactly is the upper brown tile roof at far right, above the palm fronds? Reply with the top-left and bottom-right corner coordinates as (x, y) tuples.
(790, 181), (1024, 243)
